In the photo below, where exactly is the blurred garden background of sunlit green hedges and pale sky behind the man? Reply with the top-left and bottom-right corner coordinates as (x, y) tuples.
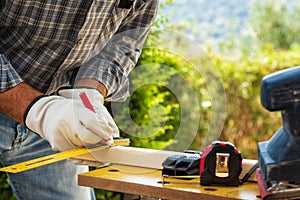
(0, 0), (300, 199)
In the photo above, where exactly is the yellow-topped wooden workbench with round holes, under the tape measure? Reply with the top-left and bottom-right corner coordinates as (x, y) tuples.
(78, 165), (259, 200)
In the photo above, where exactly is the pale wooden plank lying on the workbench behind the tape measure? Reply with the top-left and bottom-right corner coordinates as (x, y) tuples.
(76, 146), (257, 181)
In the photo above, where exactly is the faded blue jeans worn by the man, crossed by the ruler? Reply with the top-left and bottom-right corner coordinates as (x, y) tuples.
(0, 112), (95, 200)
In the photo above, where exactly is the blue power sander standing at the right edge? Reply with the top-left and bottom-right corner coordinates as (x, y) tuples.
(256, 66), (300, 199)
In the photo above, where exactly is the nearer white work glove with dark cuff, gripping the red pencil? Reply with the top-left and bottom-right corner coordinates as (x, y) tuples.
(24, 87), (115, 151)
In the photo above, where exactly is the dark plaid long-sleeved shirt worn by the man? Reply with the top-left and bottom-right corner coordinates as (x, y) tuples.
(0, 0), (158, 101)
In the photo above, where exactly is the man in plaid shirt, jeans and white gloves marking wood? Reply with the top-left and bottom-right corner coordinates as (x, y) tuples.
(0, 0), (158, 200)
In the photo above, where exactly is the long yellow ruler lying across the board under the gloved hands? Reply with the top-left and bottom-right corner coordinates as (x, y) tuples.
(0, 139), (129, 173)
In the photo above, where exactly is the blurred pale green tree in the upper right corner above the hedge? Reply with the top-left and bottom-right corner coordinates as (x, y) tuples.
(251, 0), (300, 49)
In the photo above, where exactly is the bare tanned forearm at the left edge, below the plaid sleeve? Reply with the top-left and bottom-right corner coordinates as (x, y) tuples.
(0, 83), (42, 124)
